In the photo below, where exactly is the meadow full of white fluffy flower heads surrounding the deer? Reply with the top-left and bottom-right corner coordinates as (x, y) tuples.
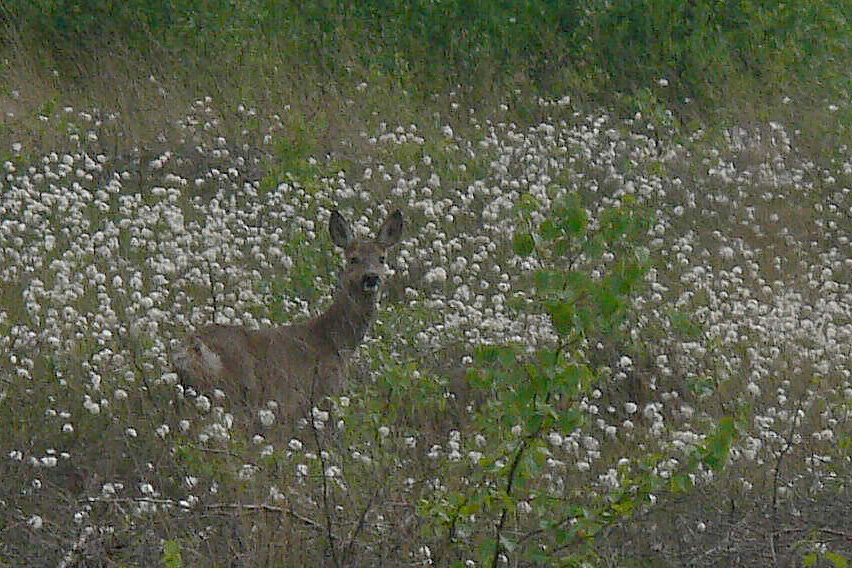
(0, 91), (852, 567)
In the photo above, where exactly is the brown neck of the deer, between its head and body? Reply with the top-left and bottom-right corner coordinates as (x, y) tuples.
(313, 289), (376, 353)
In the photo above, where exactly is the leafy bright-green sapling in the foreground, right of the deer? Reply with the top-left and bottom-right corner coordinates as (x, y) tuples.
(410, 195), (734, 566)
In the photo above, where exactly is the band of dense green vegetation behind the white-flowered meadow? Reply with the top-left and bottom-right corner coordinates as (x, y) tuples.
(0, 0), (852, 117)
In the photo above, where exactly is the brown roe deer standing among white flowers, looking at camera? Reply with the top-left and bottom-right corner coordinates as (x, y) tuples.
(172, 210), (403, 416)
